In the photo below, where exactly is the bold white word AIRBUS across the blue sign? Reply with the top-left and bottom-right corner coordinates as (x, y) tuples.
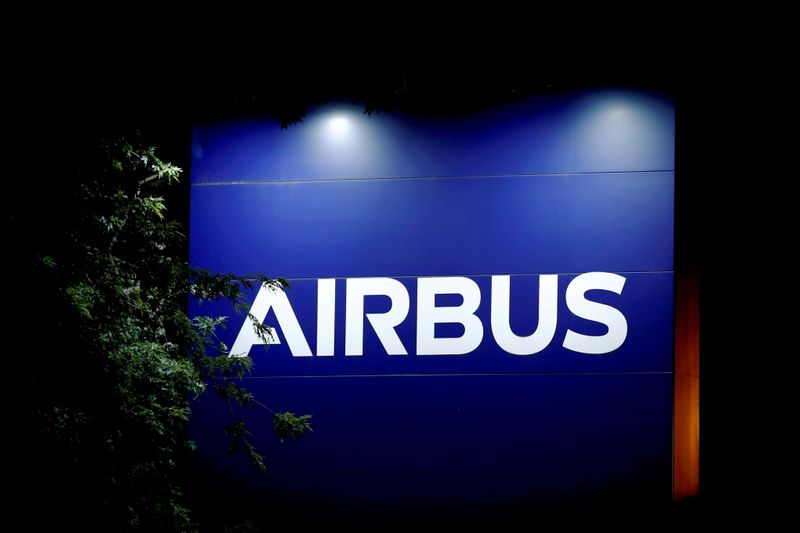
(230, 272), (628, 357)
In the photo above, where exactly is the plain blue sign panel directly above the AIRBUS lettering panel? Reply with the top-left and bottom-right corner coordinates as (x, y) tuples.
(190, 172), (673, 278)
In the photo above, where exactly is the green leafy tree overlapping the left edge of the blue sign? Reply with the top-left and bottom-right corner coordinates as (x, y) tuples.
(25, 140), (311, 531)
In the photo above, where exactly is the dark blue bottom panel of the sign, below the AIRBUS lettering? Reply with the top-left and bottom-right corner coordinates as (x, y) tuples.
(194, 374), (672, 510)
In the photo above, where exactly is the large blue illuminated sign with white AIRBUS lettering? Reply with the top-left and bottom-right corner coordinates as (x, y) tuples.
(190, 91), (674, 513)
